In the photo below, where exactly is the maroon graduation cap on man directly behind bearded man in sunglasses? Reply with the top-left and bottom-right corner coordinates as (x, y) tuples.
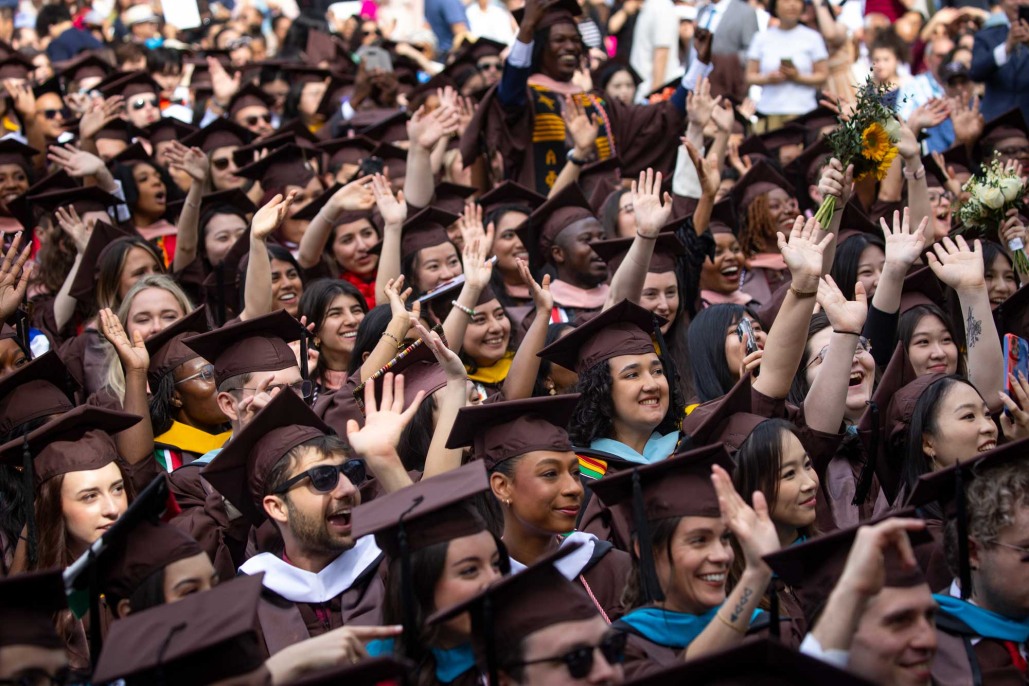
(183, 310), (306, 386)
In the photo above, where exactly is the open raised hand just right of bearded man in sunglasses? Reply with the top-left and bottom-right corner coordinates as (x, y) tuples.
(347, 371), (425, 458)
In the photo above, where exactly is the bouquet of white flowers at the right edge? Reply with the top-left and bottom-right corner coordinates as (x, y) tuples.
(955, 159), (1029, 274)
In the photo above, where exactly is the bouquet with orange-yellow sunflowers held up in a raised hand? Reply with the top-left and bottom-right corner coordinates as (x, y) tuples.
(815, 76), (900, 226)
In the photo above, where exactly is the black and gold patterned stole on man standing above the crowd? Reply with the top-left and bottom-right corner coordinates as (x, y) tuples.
(529, 84), (614, 195)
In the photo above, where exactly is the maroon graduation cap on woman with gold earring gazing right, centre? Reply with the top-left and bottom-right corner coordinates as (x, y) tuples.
(447, 394), (579, 470)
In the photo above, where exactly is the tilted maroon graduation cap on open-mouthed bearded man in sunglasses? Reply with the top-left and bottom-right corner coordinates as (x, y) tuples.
(201, 386), (337, 527)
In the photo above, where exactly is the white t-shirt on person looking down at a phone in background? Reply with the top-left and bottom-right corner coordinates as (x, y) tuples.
(747, 25), (829, 114)
